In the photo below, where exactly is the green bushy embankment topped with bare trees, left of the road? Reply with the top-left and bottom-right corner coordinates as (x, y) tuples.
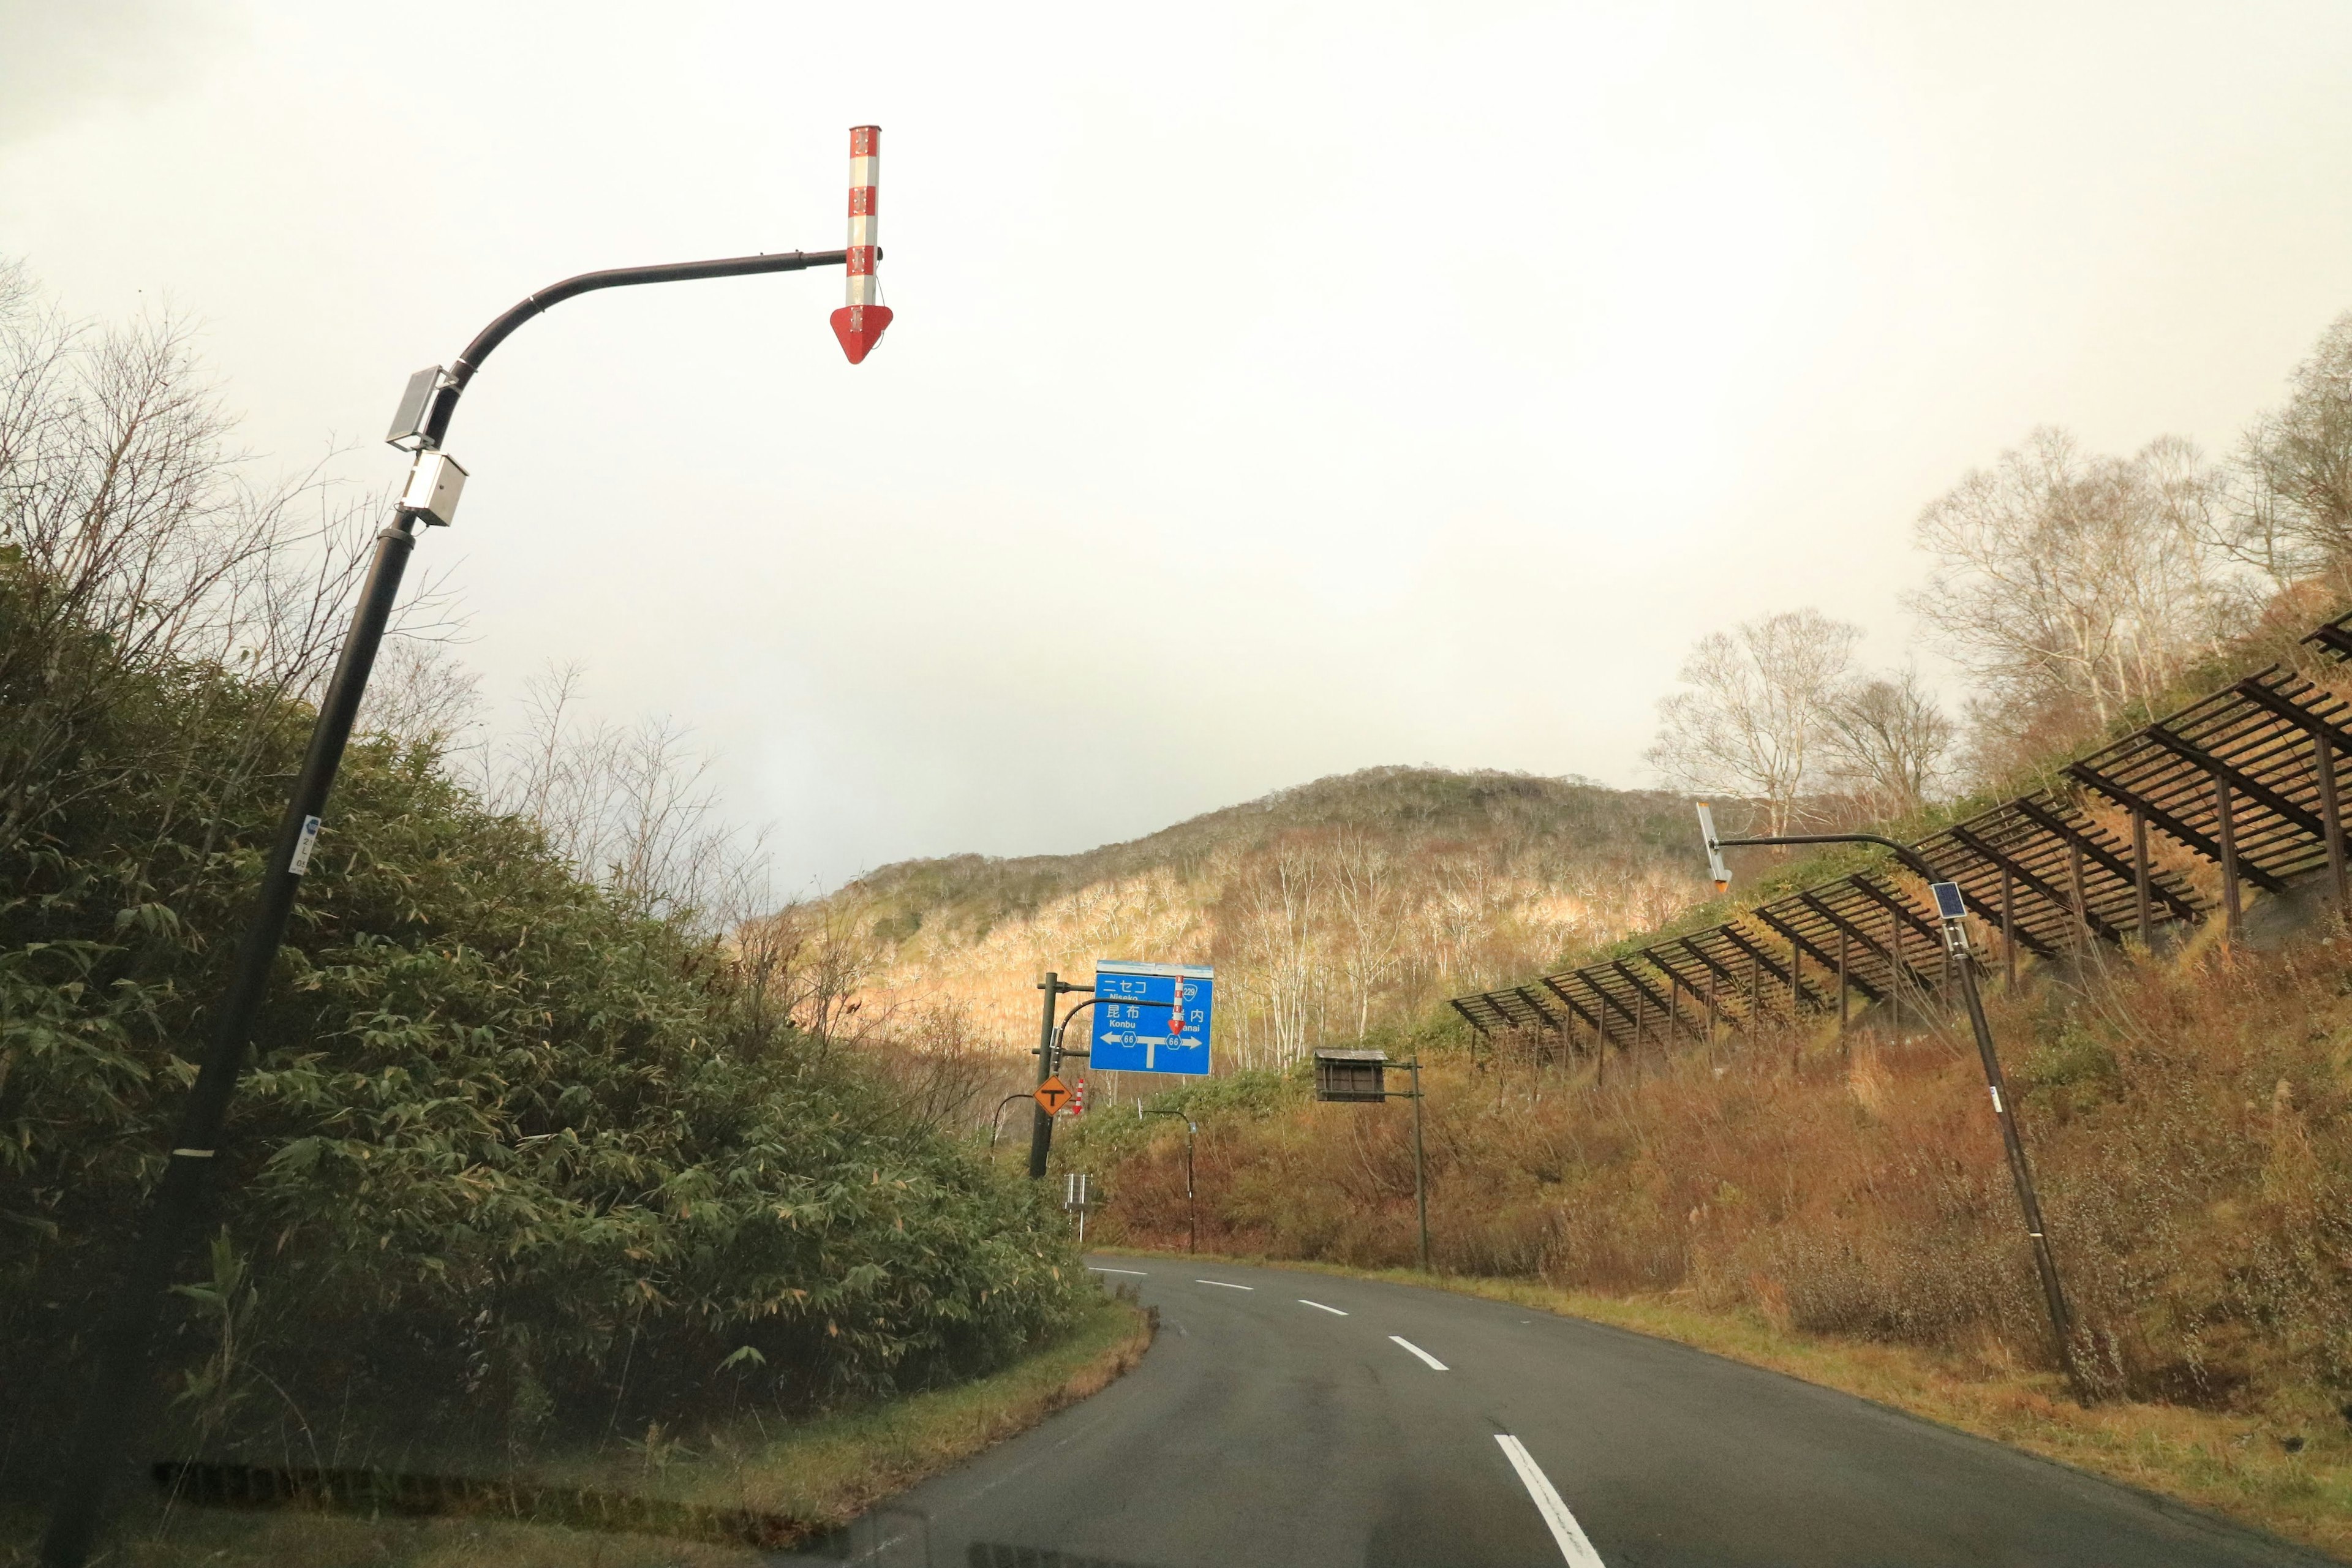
(0, 261), (1094, 1542)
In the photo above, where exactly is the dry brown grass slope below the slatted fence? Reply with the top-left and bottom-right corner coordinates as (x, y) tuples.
(1101, 931), (2352, 1549)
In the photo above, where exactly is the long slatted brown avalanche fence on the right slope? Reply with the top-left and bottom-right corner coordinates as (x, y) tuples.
(1453, 614), (2352, 1051)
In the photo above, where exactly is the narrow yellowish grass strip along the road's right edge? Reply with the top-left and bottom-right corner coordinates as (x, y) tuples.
(1096, 1246), (2352, 1561)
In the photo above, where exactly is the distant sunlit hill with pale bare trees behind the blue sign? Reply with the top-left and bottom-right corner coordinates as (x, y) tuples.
(788, 766), (1705, 1081)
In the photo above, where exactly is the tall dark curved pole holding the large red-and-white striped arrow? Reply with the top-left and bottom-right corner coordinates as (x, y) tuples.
(40, 124), (889, 1568)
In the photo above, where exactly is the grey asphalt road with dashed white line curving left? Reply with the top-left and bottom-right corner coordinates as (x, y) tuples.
(780, 1257), (2326, 1568)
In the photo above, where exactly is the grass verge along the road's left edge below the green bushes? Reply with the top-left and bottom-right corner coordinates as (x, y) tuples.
(0, 1298), (1155, 1568)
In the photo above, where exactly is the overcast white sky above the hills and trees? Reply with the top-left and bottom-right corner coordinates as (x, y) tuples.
(0, 0), (2352, 886)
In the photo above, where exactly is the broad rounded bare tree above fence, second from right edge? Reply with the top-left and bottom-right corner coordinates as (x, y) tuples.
(1910, 428), (2246, 752)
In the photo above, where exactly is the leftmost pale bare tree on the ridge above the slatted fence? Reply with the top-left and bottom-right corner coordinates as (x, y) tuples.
(1646, 609), (1860, 832)
